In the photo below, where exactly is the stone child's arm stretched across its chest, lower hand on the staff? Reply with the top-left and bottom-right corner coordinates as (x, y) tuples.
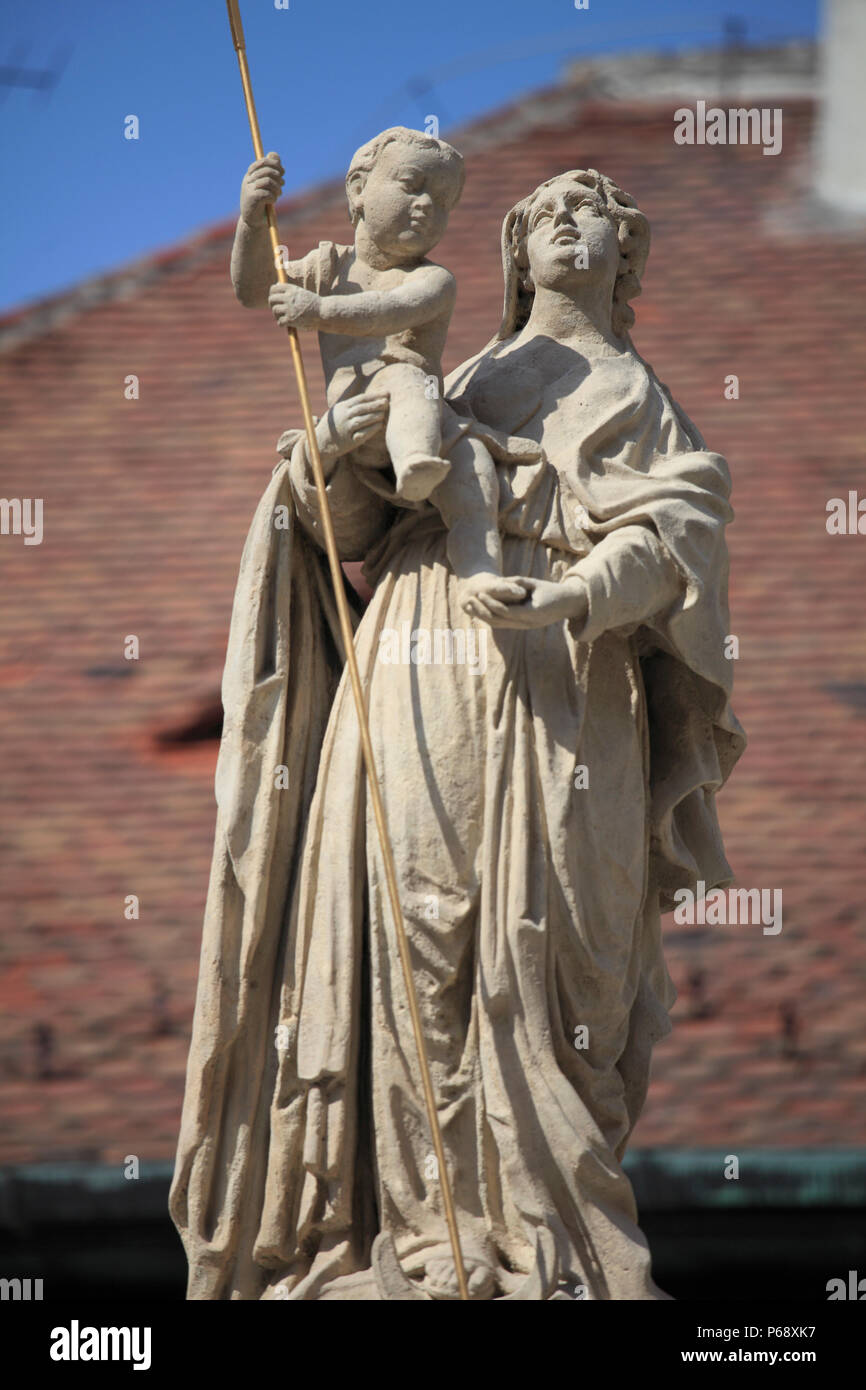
(268, 265), (457, 338)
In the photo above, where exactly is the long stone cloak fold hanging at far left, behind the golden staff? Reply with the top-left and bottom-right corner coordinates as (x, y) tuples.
(170, 463), (361, 1298)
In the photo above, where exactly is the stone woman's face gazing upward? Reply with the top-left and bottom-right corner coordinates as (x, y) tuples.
(527, 181), (620, 295)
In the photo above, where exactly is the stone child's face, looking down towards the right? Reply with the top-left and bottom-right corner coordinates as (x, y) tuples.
(360, 142), (459, 260)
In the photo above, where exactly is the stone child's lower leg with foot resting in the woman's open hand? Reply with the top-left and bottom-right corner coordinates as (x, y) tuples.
(431, 435), (525, 617)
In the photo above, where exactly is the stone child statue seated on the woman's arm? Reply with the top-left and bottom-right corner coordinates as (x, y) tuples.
(232, 126), (542, 619)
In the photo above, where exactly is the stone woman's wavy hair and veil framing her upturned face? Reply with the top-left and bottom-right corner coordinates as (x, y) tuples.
(493, 170), (649, 342)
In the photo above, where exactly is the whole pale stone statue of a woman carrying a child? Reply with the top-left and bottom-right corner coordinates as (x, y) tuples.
(171, 129), (745, 1301)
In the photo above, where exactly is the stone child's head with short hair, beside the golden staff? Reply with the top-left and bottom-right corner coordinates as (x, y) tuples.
(346, 125), (466, 260)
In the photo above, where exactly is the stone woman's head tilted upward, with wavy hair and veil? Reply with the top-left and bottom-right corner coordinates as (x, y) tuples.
(496, 170), (649, 341)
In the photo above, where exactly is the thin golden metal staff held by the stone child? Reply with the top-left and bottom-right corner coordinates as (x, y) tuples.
(227, 0), (468, 1300)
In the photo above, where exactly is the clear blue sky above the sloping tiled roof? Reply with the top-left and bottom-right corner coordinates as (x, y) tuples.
(0, 0), (819, 310)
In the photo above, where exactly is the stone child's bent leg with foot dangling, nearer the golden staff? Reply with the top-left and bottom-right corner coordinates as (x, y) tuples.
(373, 363), (450, 502)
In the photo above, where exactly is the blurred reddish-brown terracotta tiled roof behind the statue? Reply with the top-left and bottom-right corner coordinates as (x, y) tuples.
(0, 76), (866, 1162)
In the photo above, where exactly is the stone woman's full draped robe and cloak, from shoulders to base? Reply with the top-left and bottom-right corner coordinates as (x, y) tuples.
(171, 336), (744, 1300)
